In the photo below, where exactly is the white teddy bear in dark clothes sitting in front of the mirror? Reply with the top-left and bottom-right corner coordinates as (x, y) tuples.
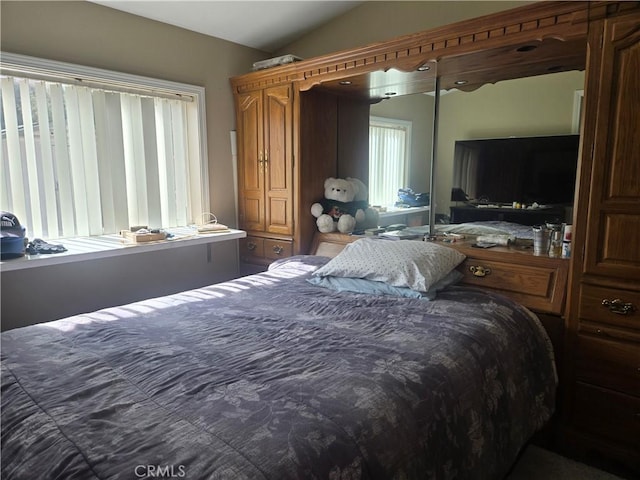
(311, 177), (378, 233)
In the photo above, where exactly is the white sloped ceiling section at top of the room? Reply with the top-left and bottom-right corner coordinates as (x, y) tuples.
(89, 0), (363, 52)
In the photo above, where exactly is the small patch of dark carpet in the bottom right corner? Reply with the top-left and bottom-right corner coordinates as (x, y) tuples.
(505, 445), (622, 480)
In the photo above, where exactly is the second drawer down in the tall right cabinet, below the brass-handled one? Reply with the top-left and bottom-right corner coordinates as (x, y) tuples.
(575, 335), (640, 396)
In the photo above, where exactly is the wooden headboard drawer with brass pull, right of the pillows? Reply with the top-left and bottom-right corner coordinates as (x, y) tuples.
(458, 255), (566, 315)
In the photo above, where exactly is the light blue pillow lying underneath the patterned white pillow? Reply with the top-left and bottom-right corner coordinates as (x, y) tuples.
(307, 270), (464, 300)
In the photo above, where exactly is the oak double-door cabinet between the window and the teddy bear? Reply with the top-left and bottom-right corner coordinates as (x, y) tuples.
(232, 79), (370, 273)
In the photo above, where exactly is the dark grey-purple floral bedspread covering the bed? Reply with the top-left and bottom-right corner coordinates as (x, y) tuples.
(1, 257), (556, 480)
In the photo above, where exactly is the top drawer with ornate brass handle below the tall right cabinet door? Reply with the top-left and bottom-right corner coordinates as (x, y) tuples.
(579, 285), (640, 330)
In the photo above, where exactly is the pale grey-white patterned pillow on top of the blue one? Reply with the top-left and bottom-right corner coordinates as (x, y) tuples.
(313, 238), (465, 292)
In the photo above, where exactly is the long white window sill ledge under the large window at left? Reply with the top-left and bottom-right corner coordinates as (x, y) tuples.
(0, 227), (247, 272)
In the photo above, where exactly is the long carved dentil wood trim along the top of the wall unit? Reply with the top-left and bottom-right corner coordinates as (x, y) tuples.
(231, 1), (600, 93)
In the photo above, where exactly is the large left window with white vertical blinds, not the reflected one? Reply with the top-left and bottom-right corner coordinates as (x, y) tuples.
(0, 53), (209, 239)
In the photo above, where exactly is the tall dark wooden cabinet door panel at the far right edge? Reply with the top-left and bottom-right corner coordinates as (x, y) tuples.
(584, 13), (640, 279)
